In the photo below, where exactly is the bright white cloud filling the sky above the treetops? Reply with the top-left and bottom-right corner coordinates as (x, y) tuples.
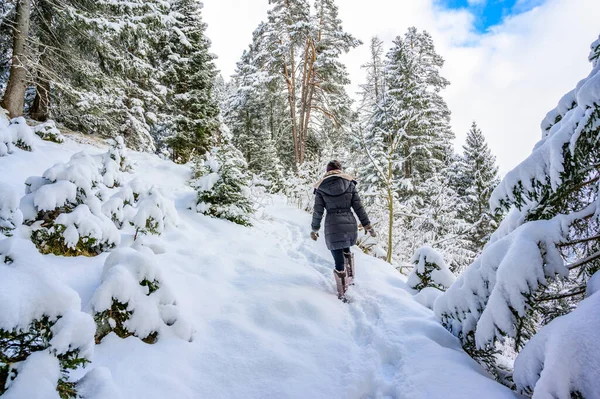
(205, 0), (600, 172)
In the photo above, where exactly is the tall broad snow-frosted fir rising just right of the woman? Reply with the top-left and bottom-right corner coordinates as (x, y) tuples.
(356, 28), (461, 262)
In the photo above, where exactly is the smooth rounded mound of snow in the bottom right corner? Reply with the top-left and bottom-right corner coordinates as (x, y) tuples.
(514, 293), (600, 399)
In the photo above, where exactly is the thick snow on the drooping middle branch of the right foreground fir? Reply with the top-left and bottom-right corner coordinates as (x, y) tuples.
(434, 206), (595, 348)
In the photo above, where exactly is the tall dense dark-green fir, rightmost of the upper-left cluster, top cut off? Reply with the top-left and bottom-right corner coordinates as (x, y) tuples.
(161, 0), (219, 163)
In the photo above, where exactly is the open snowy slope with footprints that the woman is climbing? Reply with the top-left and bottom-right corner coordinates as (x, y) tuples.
(0, 135), (514, 399)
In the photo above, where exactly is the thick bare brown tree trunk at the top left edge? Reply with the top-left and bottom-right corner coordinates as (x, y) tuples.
(0, 0), (31, 118)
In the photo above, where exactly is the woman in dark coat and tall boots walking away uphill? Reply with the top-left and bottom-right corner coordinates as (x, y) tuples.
(310, 161), (375, 302)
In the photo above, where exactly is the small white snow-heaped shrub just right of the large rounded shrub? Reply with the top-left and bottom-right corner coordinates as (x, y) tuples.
(130, 186), (178, 238)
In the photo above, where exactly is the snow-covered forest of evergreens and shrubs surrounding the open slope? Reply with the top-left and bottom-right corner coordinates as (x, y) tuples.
(0, 0), (600, 399)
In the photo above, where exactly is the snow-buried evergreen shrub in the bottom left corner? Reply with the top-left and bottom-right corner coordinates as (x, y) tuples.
(0, 238), (95, 398)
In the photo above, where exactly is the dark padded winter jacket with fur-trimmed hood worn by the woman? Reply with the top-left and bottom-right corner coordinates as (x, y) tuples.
(311, 171), (371, 250)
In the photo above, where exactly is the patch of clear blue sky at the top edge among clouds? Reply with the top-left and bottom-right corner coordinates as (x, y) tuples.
(440, 0), (544, 32)
